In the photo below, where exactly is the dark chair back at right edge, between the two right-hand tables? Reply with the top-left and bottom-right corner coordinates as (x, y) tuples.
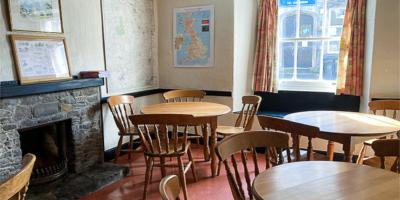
(372, 139), (400, 173)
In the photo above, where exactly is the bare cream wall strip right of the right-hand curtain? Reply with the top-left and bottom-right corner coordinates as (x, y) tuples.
(370, 0), (400, 98)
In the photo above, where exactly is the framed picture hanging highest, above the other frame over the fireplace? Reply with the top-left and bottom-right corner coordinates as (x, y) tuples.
(8, 0), (63, 33)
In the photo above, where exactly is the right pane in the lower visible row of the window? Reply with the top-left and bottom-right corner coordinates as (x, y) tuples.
(322, 40), (339, 81)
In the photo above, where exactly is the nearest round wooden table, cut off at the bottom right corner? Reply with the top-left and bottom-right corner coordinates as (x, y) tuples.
(253, 161), (400, 200)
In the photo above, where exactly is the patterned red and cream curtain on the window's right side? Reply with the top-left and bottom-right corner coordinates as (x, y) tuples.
(336, 0), (367, 96)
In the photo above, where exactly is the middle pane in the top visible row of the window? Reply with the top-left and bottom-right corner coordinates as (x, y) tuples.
(299, 0), (325, 37)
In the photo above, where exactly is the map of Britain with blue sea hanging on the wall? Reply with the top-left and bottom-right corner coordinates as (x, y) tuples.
(173, 6), (214, 67)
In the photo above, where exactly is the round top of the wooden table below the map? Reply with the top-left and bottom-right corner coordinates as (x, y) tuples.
(142, 102), (231, 117)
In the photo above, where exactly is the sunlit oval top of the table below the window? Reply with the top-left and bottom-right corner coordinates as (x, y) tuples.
(285, 111), (400, 136)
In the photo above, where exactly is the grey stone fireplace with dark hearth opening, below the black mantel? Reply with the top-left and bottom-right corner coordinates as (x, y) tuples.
(0, 87), (103, 181)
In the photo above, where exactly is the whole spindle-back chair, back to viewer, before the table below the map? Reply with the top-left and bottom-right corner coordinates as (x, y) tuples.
(130, 114), (200, 199)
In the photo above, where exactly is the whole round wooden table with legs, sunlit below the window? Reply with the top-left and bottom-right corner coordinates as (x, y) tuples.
(284, 111), (400, 162)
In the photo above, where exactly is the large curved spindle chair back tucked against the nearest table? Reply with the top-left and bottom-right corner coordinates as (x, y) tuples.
(217, 131), (291, 200)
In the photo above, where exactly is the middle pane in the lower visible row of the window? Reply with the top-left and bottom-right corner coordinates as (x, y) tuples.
(297, 41), (321, 80)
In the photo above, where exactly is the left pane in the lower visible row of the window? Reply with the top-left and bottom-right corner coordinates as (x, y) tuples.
(279, 42), (294, 79)
